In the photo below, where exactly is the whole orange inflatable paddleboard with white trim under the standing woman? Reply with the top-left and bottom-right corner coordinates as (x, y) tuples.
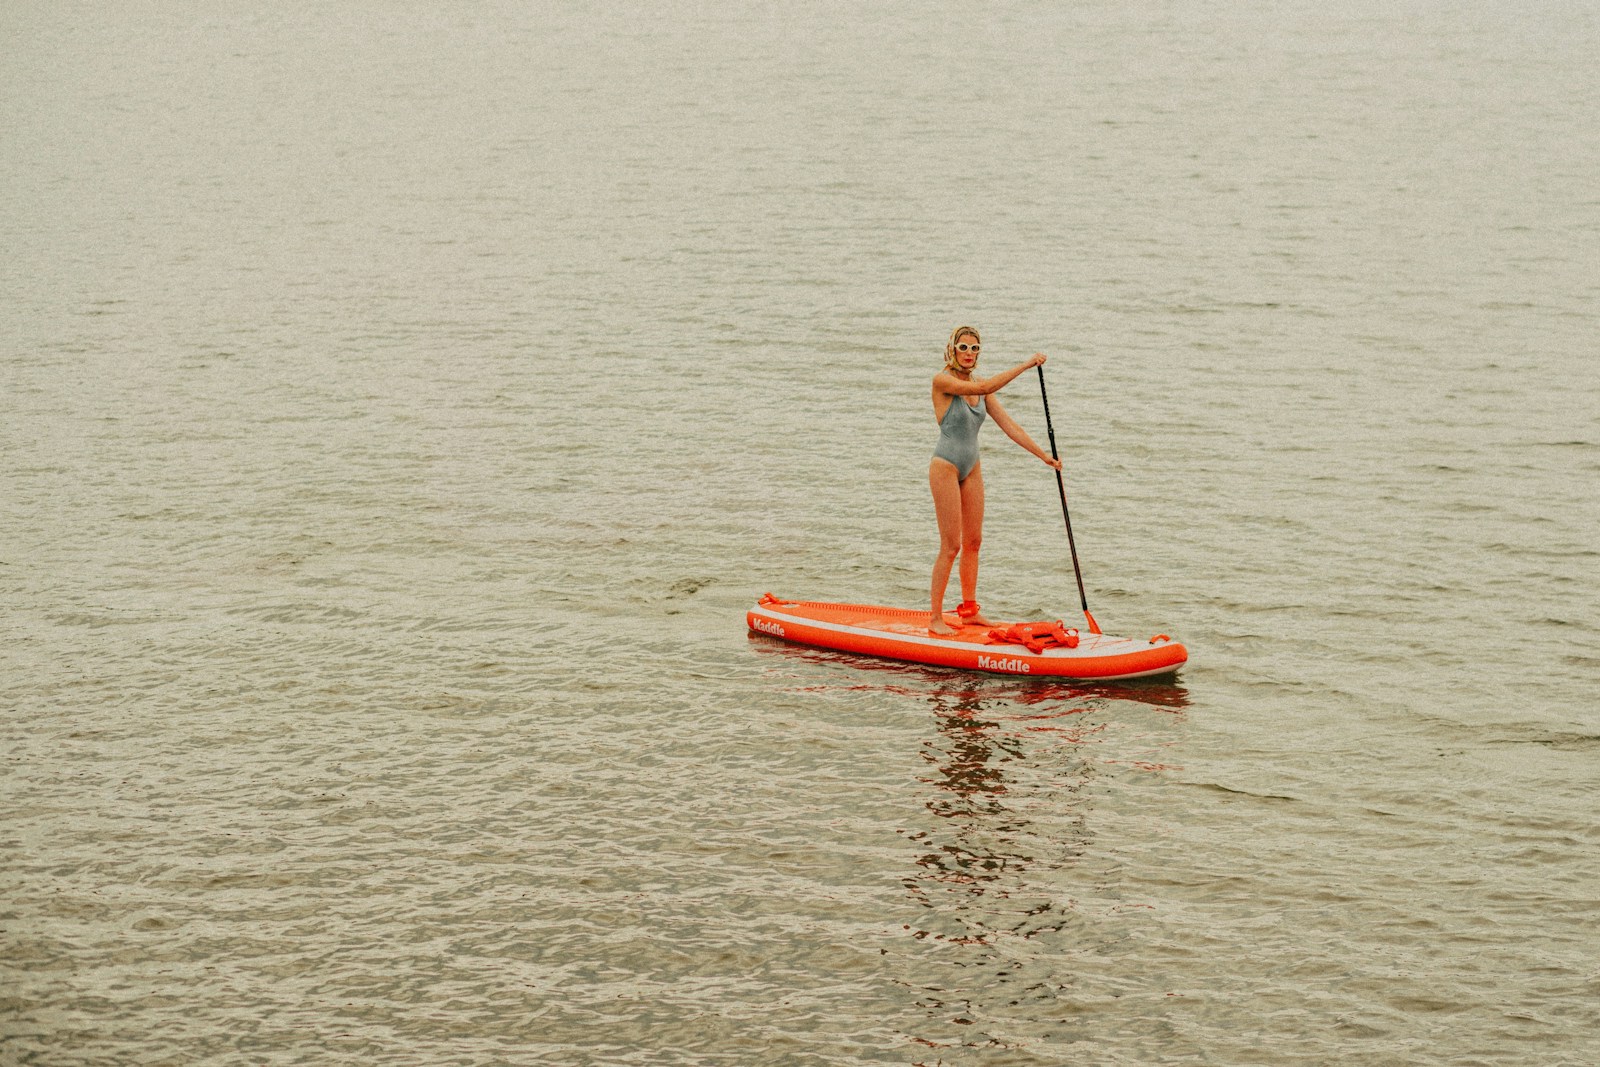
(746, 593), (1189, 681)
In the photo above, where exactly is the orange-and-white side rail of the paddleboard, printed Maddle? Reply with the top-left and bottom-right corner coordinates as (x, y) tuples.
(747, 606), (1189, 678)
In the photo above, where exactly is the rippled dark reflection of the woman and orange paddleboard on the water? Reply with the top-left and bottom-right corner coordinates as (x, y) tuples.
(750, 637), (1190, 1067)
